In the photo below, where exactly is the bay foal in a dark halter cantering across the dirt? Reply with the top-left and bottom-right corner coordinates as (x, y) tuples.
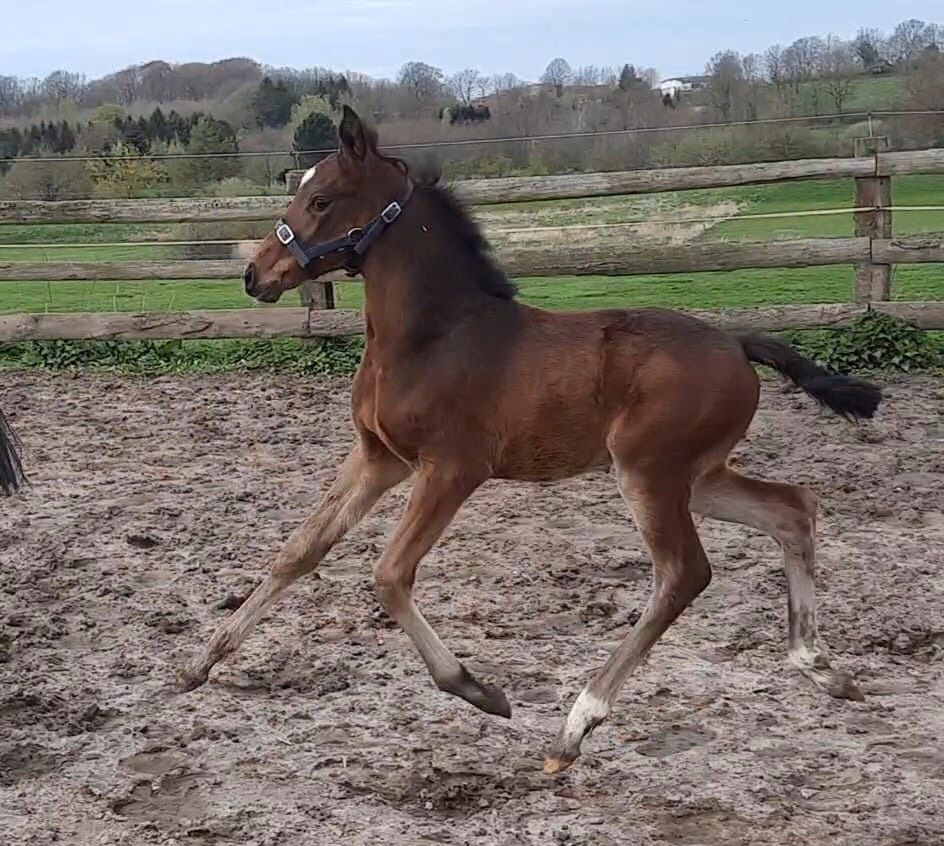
(181, 109), (881, 773)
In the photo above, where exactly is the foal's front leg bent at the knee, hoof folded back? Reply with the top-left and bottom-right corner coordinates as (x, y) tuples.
(375, 467), (511, 717)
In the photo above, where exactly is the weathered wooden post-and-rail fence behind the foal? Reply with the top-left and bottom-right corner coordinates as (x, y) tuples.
(0, 138), (944, 342)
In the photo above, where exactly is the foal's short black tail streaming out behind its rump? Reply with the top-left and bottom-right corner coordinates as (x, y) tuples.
(737, 334), (882, 420)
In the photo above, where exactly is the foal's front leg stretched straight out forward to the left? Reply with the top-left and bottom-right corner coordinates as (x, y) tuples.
(178, 434), (410, 690)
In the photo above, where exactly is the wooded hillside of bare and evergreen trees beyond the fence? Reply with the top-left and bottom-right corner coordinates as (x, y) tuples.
(0, 20), (944, 199)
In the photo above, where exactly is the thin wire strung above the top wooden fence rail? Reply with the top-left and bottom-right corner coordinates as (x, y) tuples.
(0, 109), (944, 164)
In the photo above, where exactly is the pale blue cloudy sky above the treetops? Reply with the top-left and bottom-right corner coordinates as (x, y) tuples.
(0, 0), (944, 80)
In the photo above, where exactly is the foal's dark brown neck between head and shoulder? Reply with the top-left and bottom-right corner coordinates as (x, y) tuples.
(363, 189), (518, 352)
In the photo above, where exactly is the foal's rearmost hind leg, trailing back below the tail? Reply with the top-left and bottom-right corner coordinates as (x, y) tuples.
(692, 467), (864, 700)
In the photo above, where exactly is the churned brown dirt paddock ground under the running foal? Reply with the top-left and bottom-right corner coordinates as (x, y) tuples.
(0, 372), (944, 846)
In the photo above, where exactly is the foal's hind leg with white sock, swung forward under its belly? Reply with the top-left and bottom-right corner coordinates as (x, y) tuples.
(544, 465), (711, 774)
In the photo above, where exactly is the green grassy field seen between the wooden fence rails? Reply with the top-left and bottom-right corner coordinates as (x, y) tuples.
(0, 176), (944, 313)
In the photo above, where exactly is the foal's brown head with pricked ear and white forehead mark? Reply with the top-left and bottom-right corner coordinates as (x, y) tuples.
(243, 106), (407, 303)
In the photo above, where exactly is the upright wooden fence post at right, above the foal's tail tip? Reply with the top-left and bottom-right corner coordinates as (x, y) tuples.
(855, 135), (892, 303)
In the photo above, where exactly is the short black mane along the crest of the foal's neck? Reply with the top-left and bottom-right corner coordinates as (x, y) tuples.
(380, 152), (518, 300)
